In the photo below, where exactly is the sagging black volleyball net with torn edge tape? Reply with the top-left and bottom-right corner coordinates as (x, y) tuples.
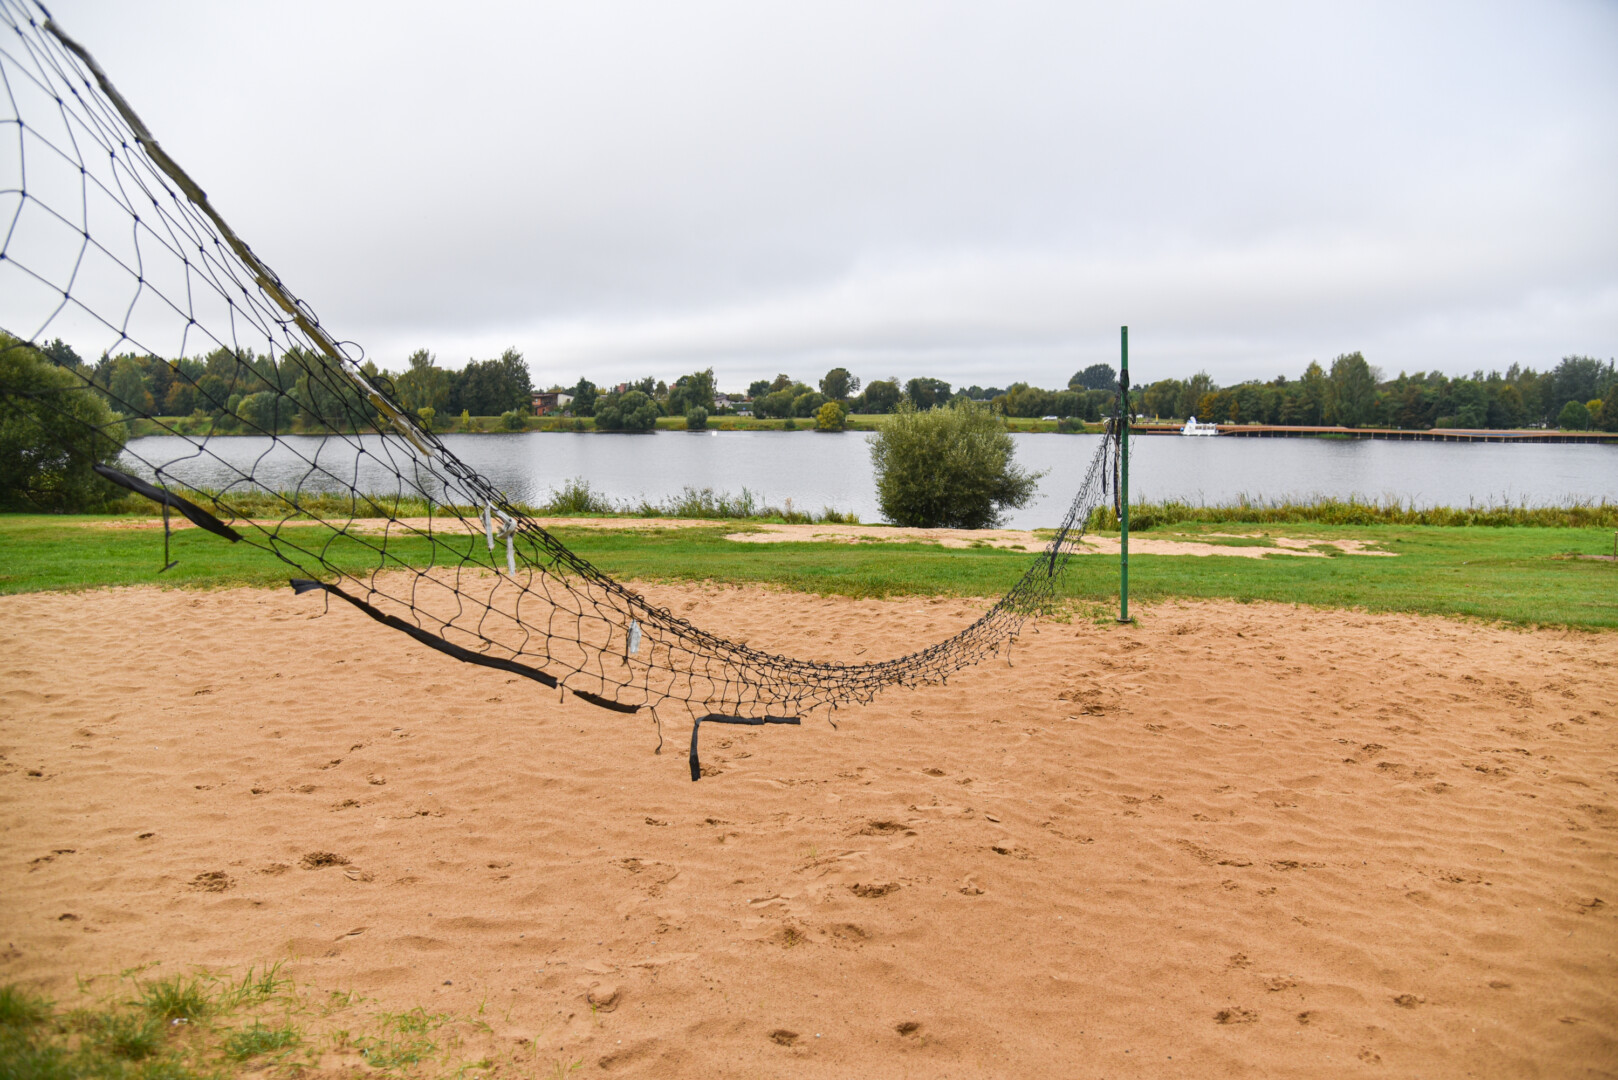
(0, 0), (1110, 779)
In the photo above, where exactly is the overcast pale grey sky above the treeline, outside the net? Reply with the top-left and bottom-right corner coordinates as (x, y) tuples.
(38, 0), (1618, 389)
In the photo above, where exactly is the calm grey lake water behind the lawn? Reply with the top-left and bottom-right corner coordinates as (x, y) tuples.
(129, 431), (1618, 528)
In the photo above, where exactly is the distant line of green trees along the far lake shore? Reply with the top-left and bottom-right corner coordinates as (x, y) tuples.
(28, 340), (1618, 431)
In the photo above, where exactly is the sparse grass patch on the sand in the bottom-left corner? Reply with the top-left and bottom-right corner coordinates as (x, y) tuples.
(0, 965), (524, 1080)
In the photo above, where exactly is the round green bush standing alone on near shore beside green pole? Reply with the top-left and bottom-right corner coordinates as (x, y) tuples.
(870, 400), (1040, 529)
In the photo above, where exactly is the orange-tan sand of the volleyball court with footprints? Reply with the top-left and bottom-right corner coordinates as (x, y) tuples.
(0, 586), (1618, 1078)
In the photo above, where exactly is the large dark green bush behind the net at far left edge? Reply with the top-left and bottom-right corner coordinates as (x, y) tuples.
(0, 332), (123, 513)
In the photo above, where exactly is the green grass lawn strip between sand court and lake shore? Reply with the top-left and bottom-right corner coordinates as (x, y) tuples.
(0, 515), (1618, 628)
